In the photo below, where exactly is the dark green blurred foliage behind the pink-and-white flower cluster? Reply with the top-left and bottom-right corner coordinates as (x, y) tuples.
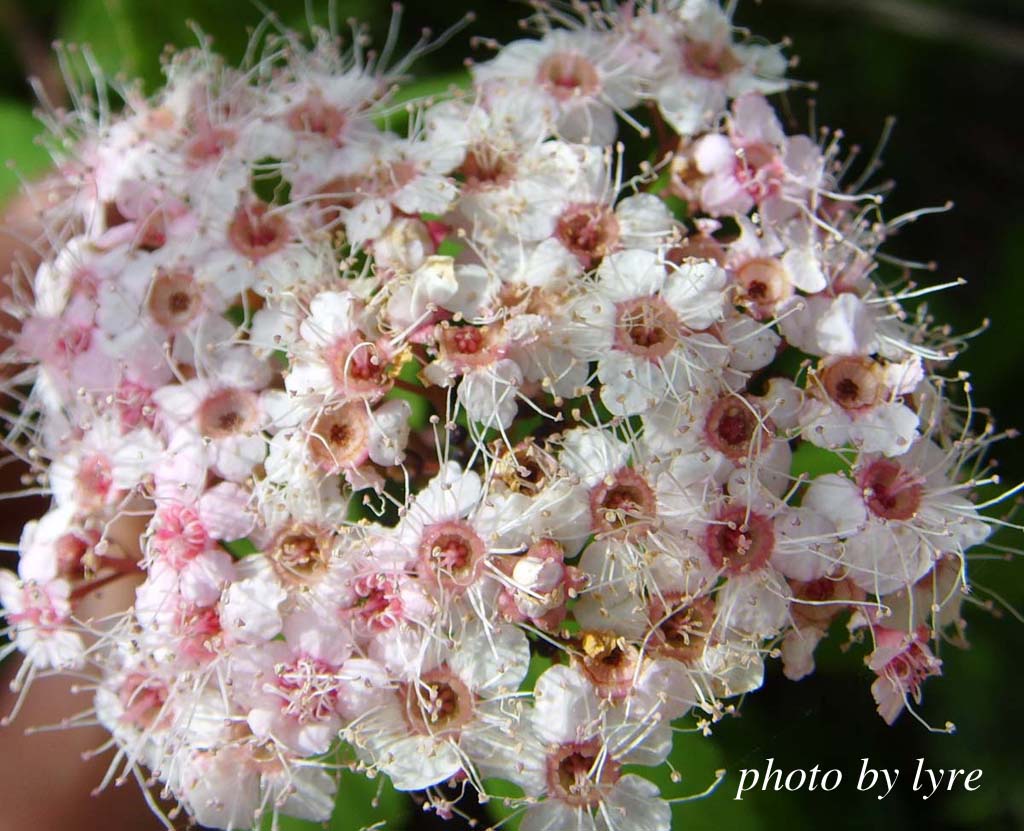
(0, 0), (1024, 831)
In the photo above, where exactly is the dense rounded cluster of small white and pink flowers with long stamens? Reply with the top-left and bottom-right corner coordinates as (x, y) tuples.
(0, 0), (1007, 831)
